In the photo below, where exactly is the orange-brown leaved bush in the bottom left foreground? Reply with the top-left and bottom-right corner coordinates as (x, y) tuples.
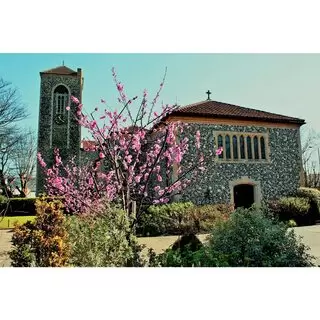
(9, 197), (69, 267)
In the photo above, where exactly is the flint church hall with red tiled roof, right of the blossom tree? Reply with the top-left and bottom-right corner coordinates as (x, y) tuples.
(167, 99), (305, 207)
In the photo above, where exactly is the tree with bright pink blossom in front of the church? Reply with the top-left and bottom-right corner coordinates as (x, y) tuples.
(38, 69), (221, 224)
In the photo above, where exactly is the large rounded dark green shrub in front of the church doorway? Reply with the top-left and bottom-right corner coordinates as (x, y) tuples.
(208, 208), (313, 267)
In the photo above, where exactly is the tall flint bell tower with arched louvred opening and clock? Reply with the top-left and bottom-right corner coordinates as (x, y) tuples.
(36, 65), (83, 195)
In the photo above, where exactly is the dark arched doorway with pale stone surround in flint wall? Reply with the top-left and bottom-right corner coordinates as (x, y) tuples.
(229, 176), (262, 208)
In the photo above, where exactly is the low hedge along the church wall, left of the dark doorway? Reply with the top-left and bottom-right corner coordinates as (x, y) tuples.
(136, 202), (232, 236)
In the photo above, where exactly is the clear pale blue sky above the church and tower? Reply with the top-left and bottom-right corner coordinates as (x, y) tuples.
(0, 53), (320, 136)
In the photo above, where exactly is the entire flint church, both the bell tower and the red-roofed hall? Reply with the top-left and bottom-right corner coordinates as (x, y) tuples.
(37, 66), (305, 207)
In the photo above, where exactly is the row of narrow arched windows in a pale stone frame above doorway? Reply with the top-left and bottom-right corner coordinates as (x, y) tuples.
(215, 131), (270, 163)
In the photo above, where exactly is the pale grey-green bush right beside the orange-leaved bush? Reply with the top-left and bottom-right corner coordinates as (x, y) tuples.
(67, 206), (144, 267)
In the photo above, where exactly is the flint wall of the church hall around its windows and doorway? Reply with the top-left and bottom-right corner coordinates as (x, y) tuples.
(180, 124), (301, 204)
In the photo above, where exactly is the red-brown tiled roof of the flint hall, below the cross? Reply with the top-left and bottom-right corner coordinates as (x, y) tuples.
(171, 100), (305, 125)
